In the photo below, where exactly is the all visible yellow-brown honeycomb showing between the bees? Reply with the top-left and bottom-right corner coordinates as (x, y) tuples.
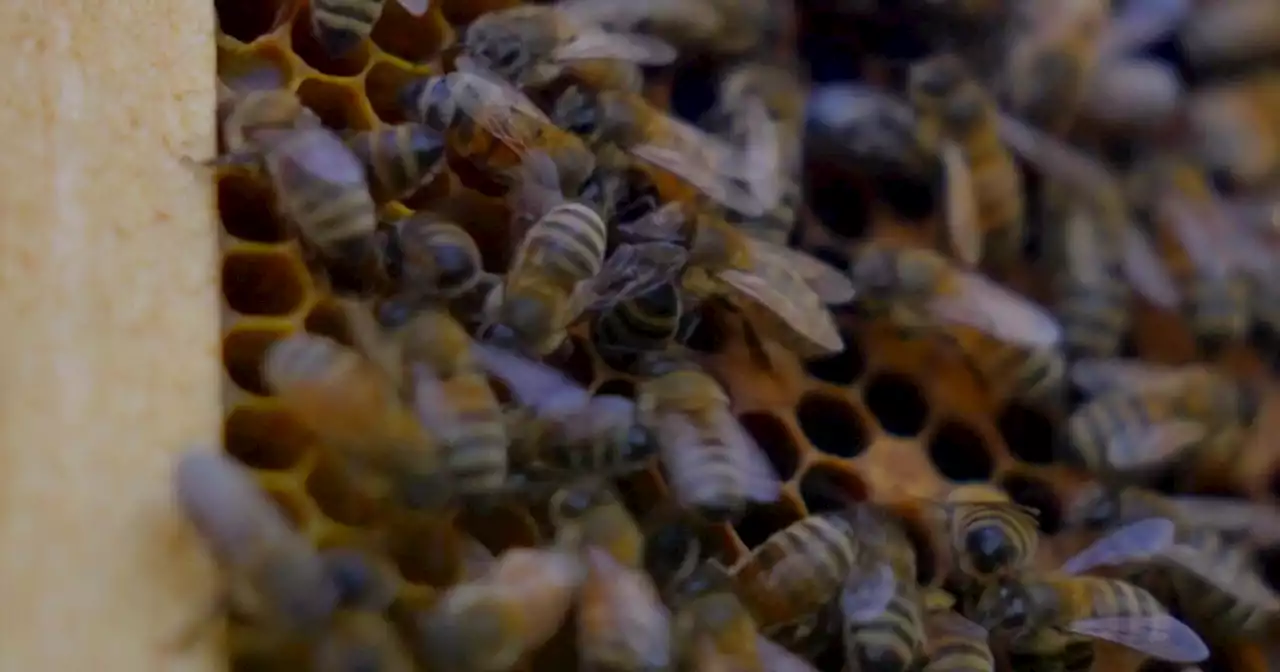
(215, 0), (1280, 671)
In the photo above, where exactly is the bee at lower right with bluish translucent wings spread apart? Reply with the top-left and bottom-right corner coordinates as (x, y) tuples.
(975, 518), (1208, 663)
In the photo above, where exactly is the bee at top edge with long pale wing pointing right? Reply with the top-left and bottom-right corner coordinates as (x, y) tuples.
(458, 5), (676, 91)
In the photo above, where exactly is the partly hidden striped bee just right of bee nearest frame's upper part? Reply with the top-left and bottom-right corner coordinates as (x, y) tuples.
(347, 124), (445, 201)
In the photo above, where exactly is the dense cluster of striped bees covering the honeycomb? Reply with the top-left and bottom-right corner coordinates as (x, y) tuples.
(199, 0), (1280, 672)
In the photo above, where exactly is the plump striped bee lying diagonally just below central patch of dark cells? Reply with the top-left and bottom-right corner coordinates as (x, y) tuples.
(731, 506), (893, 628)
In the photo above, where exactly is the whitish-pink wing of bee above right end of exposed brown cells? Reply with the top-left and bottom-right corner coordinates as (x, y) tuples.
(929, 269), (1062, 347)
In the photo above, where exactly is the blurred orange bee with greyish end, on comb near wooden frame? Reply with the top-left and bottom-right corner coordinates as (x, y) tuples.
(262, 332), (443, 506)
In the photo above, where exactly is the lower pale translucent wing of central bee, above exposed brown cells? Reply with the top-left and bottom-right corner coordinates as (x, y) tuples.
(717, 266), (845, 357)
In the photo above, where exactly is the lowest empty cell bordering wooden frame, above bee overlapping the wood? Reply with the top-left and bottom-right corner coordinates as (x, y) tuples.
(223, 404), (314, 470)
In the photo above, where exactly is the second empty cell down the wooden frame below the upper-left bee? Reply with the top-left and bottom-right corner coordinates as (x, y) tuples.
(223, 250), (307, 315)
